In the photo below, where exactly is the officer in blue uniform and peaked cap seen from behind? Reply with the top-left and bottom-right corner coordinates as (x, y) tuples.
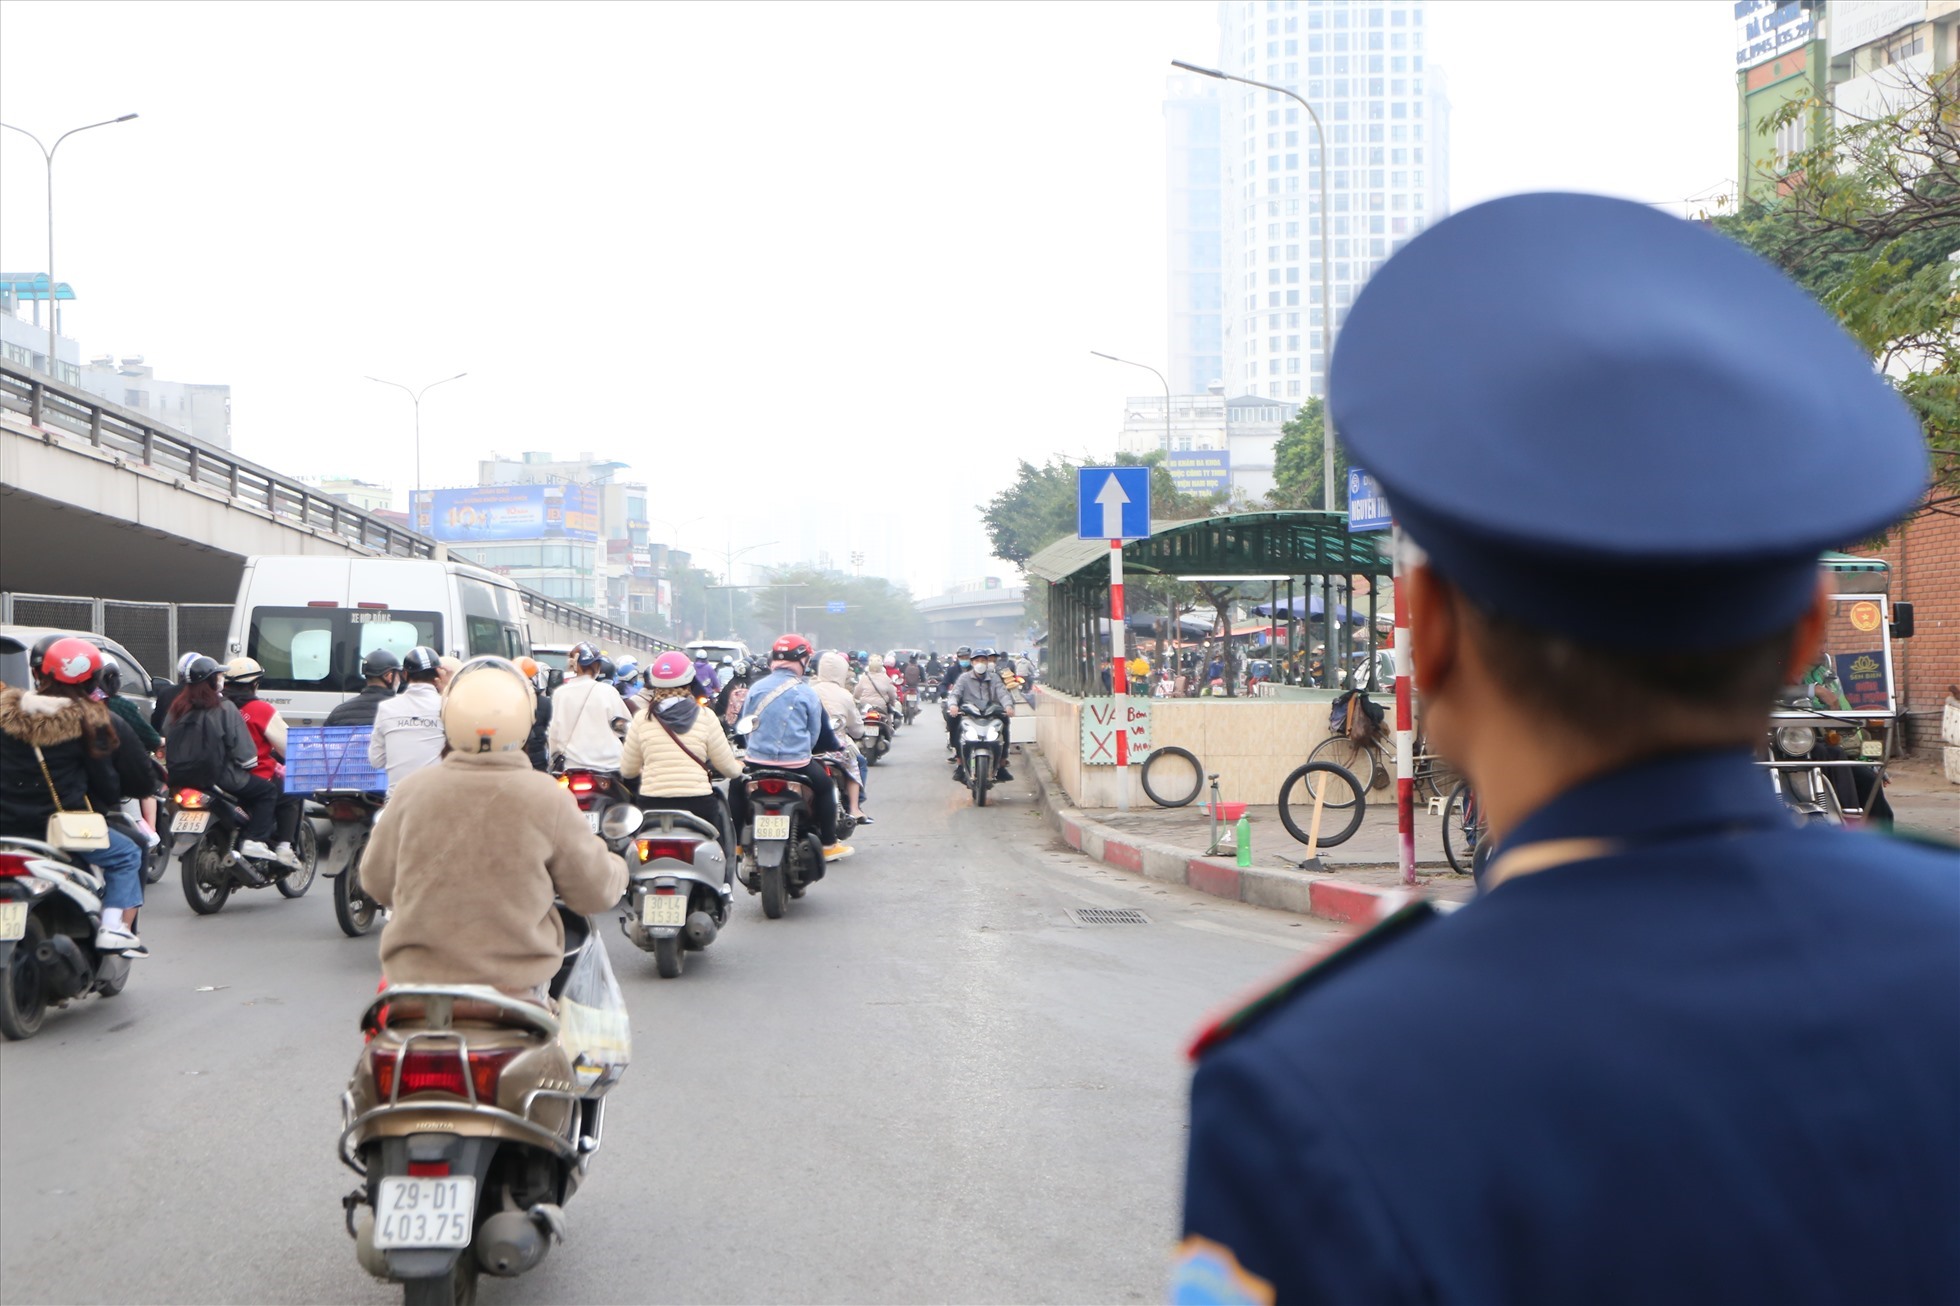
(1172, 194), (1960, 1304)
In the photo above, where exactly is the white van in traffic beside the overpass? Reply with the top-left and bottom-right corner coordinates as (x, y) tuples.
(229, 555), (531, 726)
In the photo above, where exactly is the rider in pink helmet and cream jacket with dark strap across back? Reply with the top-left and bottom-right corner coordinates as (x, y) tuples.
(619, 653), (741, 854)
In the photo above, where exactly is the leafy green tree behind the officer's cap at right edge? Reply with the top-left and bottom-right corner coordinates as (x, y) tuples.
(1713, 69), (1960, 496)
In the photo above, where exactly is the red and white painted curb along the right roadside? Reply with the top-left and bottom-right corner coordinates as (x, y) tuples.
(1023, 745), (1409, 926)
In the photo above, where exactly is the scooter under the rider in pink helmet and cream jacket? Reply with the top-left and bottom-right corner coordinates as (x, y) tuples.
(619, 800), (733, 979)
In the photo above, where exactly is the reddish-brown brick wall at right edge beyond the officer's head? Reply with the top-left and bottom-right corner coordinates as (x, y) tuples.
(1862, 498), (1960, 749)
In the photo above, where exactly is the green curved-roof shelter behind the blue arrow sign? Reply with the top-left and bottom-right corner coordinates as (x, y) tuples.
(1025, 510), (1394, 696)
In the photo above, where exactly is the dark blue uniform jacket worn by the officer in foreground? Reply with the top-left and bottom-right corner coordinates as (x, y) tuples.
(1174, 753), (1960, 1304)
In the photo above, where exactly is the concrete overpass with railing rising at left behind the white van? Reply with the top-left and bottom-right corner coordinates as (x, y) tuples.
(0, 361), (670, 653)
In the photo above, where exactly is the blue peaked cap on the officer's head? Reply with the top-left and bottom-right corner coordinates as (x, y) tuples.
(1329, 194), (1927, 651)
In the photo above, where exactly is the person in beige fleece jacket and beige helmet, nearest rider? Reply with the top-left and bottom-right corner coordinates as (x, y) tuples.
(361, 657), (627, 1006)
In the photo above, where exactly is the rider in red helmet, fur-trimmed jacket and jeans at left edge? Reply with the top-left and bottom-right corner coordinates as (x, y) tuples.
(0, 635), (153, 953)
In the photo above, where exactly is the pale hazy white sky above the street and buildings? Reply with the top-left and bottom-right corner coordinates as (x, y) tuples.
(0, 0), (1735, 592)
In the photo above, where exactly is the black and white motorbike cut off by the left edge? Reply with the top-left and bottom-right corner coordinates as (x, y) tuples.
(0, 839), (129, 1039)
